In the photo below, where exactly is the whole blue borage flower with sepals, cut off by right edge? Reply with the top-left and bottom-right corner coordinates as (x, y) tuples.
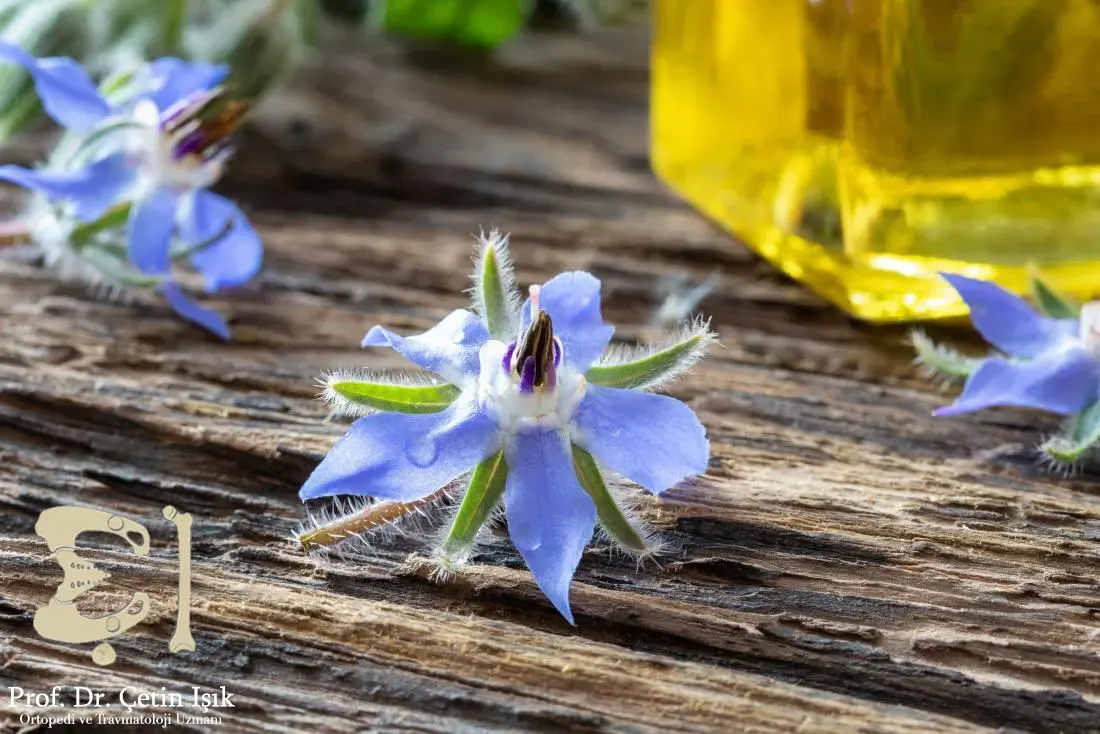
(914, 273), (1100, 465)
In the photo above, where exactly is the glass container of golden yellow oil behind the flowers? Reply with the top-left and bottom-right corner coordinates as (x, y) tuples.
(651, 0), (1100, 321)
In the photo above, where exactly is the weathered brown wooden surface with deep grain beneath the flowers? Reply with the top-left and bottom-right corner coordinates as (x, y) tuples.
(0, 28), (1100, 732)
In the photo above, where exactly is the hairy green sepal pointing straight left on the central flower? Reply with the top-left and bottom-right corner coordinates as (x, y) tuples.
(321, 371), (461, 416)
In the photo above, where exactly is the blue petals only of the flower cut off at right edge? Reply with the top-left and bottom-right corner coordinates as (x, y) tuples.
(935, 274), (1100, 416)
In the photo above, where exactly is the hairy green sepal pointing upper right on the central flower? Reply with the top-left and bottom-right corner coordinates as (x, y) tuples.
(584, 319), (717, 390)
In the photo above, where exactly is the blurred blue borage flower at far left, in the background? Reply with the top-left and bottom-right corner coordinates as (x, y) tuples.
(0, 43), (263, 339)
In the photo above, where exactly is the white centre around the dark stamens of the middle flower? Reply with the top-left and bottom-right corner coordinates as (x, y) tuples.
(477, 340), (586, 434)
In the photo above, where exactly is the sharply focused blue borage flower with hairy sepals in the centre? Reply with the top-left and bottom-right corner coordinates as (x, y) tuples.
(299, 232), (714, 623)
